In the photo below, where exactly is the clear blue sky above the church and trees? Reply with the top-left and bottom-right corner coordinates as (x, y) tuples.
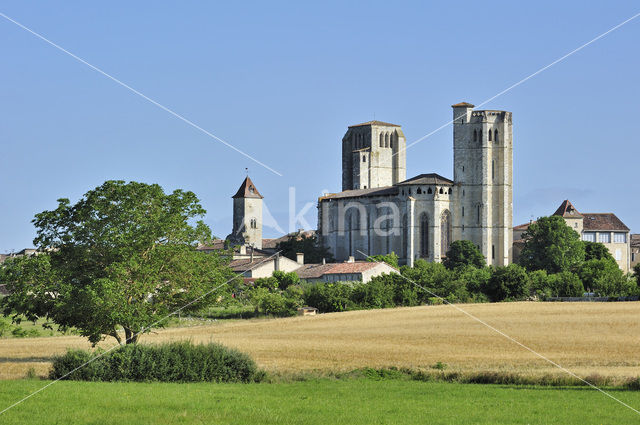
(0, 1), (640, 252)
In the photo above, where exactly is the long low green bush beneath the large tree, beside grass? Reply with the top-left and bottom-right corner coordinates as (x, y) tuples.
(49, 342), (264, 382)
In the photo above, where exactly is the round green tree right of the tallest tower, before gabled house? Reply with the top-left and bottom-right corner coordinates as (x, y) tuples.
(520, 215), (585, 273)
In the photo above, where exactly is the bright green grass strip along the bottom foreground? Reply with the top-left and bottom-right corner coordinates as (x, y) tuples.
(0, 379), (640, 425)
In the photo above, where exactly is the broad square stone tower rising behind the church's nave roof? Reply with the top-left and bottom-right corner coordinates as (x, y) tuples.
(342, 121), (407, 191)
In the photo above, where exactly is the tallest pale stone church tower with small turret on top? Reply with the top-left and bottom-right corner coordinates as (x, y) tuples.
(452, 102), (513, 266)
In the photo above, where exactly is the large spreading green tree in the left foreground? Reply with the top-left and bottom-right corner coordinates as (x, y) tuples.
(0, 181), (233, 344)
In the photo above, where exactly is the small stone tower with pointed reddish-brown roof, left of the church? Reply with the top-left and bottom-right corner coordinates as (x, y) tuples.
(227, 176), (263, 249)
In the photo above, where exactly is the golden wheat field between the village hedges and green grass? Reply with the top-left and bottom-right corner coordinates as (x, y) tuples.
(0, 302), (640, 379)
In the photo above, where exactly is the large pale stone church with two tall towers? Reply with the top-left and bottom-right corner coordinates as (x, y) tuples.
(317, 102), (513, 266)
